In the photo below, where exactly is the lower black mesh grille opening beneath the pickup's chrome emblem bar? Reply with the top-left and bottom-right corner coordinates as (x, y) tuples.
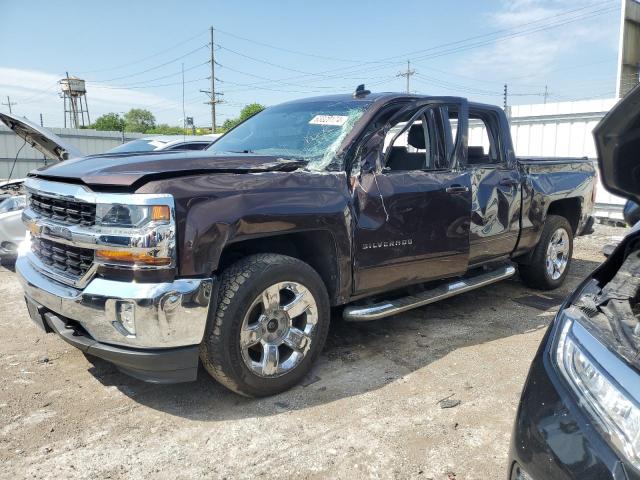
(31, 237), (93, 278)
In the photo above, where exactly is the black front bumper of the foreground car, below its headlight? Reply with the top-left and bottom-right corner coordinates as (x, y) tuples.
(509, 322), (640, 480)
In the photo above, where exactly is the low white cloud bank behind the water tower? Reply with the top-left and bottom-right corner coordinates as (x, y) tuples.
(0, 67), (188, 127)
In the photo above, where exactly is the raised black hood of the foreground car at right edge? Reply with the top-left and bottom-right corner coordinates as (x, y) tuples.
(593, 85), (640, 202)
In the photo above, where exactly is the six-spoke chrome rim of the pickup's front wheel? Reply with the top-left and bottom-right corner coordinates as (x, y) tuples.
(240, 282), (318, 378)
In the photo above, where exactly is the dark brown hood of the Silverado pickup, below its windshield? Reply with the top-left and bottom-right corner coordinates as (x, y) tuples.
(31, 150), (306, 187)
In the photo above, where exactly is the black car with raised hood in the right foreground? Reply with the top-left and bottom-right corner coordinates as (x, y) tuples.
(509, 87), (640, 480)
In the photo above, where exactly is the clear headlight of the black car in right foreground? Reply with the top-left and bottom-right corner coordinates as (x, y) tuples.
(555, 307), (640, 468)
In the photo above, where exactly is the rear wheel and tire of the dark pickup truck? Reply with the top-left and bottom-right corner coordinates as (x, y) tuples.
(518, 215), (573, 290)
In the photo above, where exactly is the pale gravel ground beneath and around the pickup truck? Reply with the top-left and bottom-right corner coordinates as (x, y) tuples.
(0, 226), (625, 480)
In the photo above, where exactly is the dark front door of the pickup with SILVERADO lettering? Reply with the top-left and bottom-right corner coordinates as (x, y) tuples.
(353, 102), (471, 294)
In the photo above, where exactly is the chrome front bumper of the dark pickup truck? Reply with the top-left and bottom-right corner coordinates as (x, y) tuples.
(16, 253), (214, 381)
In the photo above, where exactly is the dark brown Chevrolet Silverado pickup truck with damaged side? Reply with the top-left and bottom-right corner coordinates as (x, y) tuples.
(8, 86), (595, 396)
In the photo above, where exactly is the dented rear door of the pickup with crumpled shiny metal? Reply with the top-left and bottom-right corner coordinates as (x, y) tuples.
(466, 106), (522, 265)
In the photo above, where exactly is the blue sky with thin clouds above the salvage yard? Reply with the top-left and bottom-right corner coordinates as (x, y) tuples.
(0, 0), (620, 126)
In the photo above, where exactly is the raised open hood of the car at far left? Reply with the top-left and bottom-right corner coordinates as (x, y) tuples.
(0, 113), (83, 161)
